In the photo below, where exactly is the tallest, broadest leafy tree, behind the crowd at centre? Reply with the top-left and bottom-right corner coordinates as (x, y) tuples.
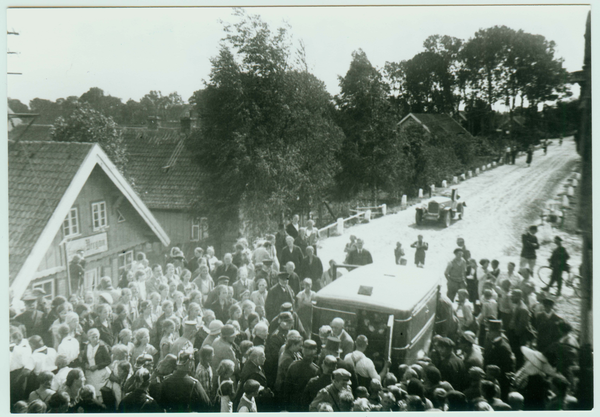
(190, 9), (343, 236)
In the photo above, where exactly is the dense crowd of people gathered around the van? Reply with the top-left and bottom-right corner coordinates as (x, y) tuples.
(10, 216), (578, 413)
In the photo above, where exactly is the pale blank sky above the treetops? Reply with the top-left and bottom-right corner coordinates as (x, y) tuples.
(7, 5), (589, 104)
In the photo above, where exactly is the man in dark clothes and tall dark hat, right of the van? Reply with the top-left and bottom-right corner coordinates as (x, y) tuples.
(483, 319), (515, 401)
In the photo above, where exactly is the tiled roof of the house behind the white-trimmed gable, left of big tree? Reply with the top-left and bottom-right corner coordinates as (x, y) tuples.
(123, 128), (202, 210)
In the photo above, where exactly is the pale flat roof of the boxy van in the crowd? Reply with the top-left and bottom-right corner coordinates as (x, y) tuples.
(316, 264), (440, 311)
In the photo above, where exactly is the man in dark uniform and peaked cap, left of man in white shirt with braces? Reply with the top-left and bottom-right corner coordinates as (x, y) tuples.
(284, 339), (319, 411)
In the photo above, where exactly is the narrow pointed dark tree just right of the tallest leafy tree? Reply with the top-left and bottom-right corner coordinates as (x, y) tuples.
(336, 49), (402, 202)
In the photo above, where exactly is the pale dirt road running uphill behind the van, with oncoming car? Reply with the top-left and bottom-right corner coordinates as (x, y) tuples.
(319, 138), (580, 304)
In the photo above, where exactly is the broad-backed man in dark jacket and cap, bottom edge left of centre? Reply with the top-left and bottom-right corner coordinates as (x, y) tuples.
(158, 344), (211, 413)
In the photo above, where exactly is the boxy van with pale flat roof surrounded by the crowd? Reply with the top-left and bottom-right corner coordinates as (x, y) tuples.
(312, 264), (440, 369)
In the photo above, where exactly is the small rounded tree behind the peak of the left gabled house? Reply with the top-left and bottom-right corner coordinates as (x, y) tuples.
(50, 103), (127, 172)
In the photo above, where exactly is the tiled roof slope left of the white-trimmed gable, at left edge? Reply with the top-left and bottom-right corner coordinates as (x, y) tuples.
(8, 141), (94, 284)
